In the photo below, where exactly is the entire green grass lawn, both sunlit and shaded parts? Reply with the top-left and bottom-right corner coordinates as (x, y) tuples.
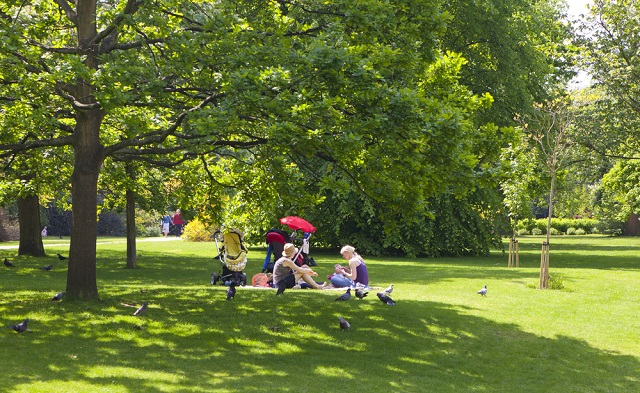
(0, 236), (640, 393)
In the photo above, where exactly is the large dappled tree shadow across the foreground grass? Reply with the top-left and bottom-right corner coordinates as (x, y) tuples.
(0, 288), (640, 392)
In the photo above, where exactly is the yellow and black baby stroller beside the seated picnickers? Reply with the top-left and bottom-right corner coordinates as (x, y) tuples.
(211, 229), (249, 286)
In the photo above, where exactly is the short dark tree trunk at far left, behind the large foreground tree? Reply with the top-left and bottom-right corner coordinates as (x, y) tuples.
(18, 195), (45, 257)
